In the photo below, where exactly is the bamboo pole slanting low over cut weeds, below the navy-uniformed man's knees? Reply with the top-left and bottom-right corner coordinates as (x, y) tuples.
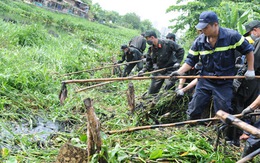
(106, 114), (242, 134)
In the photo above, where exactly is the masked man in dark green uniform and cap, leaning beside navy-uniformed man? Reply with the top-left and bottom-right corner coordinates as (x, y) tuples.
(139, 30), (184, 94)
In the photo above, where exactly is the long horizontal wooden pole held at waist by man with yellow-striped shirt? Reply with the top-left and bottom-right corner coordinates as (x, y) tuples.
(62, 76), (260, 84)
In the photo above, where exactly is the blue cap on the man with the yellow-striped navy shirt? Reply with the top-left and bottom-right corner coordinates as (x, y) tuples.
(195, 11), (218, 30)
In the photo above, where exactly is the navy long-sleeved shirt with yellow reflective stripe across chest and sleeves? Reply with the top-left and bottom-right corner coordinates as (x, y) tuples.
(185, 27), (254, 76)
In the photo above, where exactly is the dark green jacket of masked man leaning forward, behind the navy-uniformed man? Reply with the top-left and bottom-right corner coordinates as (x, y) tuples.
(146, 39), (184, 70)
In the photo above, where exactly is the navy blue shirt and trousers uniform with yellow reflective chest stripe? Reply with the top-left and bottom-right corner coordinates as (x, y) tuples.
(185, 27), (254, 119)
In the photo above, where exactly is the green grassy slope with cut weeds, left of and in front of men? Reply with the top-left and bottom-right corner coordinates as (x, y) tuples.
(0, 0), (256, 162)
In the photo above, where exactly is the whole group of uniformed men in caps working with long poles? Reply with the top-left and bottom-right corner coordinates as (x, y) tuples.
(119, 11), (260, 159)
